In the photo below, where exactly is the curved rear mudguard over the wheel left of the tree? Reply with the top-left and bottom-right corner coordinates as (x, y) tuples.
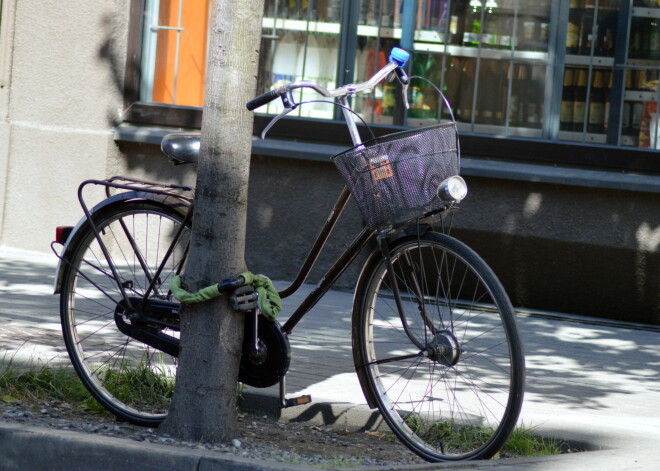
(53, 191), (190, 294)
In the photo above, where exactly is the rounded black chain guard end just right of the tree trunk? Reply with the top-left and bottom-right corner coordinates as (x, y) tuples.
(238, 315), (291, 388)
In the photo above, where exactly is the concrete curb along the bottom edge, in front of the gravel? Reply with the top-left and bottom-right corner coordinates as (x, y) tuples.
(0, 423), (620, 471)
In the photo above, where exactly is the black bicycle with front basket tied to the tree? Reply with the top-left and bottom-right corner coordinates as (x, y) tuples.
(53, 48), (524, 461)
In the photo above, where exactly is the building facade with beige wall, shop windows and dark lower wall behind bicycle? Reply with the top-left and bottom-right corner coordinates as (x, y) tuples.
(0, 0), (660, 324)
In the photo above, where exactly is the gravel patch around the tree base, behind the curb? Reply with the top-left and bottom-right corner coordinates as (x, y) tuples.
(0, 398), (424, 467)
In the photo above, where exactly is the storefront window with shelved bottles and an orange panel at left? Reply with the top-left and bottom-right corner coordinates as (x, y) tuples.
(129, 0), (660, 165)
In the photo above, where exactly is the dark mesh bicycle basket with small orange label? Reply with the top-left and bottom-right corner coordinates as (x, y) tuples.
(332, 122), (460, 230)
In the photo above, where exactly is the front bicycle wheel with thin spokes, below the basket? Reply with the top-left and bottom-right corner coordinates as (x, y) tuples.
(353, 232), (524, 461)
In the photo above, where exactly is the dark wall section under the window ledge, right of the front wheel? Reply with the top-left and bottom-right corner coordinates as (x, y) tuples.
(454, 178), (660, 324)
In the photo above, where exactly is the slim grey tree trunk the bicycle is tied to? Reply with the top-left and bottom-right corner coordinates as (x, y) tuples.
(161, 0), (263, 442)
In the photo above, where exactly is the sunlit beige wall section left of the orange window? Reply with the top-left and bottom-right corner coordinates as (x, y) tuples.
(0, 0), (130, 251)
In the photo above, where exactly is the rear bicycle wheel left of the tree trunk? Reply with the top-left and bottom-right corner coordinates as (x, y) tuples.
(60, 200), (190, 426)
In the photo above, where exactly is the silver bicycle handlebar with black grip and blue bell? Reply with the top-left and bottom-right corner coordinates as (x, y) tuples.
(246, 47), (410, 111)
